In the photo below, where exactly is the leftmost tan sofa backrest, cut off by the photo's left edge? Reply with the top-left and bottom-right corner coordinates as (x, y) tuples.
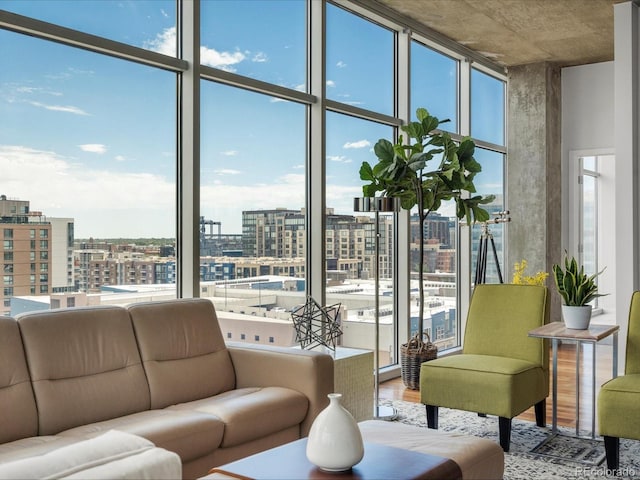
(0, 316), (38, 443)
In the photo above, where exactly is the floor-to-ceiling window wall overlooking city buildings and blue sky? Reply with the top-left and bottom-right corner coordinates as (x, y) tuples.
(0, 0), (505, 372)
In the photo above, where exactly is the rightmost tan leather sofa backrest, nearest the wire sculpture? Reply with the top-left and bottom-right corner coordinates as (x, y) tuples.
(128, 298), (235, 408)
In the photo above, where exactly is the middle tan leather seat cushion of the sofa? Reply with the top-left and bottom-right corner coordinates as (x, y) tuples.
(59, 410), (224, 463)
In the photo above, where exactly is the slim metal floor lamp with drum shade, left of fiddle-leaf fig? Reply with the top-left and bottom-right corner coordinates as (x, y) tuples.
(353, 197), (398, 420)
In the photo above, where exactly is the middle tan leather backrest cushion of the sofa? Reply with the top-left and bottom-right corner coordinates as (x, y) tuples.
(16, 306), (150, 435)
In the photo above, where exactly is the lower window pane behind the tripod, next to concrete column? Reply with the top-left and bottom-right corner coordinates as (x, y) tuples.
(471, 147), (504, 283)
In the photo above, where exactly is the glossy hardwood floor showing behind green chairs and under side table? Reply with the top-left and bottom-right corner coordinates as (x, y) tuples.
(380, 342), (623, 432)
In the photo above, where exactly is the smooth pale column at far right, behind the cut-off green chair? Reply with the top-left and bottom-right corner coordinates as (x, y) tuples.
(614, 2), (640, 373)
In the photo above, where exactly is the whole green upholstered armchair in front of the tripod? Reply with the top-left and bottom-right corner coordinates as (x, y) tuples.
(420, 284), (549, 452)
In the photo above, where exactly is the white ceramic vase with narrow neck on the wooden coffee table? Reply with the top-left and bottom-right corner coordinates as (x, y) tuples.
(307, 393), (364, 472)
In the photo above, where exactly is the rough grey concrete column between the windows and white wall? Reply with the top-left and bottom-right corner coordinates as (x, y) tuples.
(504, 63), (562, 321)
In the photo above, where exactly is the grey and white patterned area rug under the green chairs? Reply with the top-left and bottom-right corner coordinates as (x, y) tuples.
(380, 400), (640, 480)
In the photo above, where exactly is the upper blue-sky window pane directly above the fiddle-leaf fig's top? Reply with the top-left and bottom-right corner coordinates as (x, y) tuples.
(411, 41), (459, 133)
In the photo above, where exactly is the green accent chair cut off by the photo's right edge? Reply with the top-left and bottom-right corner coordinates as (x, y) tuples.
(597, 292), (640, 470)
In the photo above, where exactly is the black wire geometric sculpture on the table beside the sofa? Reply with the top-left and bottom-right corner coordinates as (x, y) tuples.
(291, 296), (342, 351)
